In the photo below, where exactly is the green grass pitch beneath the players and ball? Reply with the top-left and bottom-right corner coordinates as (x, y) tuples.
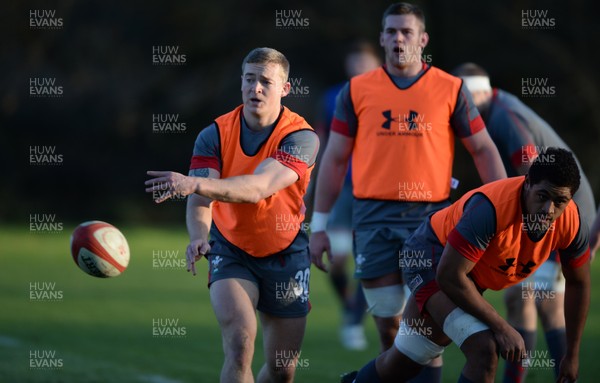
(0, 226), (600, 383)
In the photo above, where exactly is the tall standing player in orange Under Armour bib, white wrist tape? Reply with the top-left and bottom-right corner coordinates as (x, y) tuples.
(310, 3), (506, 382)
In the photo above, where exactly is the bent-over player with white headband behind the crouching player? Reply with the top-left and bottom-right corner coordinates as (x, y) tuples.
(452, 63), (596, 383)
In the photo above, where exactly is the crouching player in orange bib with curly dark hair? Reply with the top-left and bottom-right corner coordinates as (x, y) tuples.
(342, 148), (591, 383)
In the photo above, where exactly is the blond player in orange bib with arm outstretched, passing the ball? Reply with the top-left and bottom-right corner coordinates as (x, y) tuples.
(146, 48), (319, 383)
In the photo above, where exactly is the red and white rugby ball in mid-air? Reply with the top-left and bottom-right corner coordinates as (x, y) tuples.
(71, 221), (130, 278)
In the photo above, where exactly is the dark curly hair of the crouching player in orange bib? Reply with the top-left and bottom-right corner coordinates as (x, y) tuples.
(527, 147), (581, 195)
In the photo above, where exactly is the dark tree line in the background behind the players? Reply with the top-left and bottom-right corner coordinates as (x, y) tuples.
(0, 0), (600, 223)
